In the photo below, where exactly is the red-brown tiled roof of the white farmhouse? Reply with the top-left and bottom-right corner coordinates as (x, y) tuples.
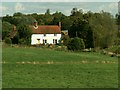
(30, 25), (61, 34)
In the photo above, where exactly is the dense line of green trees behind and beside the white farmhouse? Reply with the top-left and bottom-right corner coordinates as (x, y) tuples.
(2, 8), (120, 48)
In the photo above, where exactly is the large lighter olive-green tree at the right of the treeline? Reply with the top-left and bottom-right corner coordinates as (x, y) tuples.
(89, 11), (117, 48)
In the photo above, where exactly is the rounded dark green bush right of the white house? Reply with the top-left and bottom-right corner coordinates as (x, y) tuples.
(67, 37), (85, 51)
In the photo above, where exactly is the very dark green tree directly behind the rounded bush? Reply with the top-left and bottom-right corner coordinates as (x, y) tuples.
(69, 18), (93, 48)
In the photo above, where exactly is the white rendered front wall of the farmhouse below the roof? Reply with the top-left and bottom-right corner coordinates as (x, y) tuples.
(31, 34), (61, 45)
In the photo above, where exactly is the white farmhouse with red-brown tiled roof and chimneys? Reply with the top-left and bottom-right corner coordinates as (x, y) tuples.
(31, 22), (61, 45)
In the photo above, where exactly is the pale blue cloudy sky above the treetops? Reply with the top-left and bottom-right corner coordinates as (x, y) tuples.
(0, 0), (118, 16)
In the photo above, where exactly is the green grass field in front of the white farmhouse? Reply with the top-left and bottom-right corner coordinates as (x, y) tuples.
(1, 47), (118, 88)
